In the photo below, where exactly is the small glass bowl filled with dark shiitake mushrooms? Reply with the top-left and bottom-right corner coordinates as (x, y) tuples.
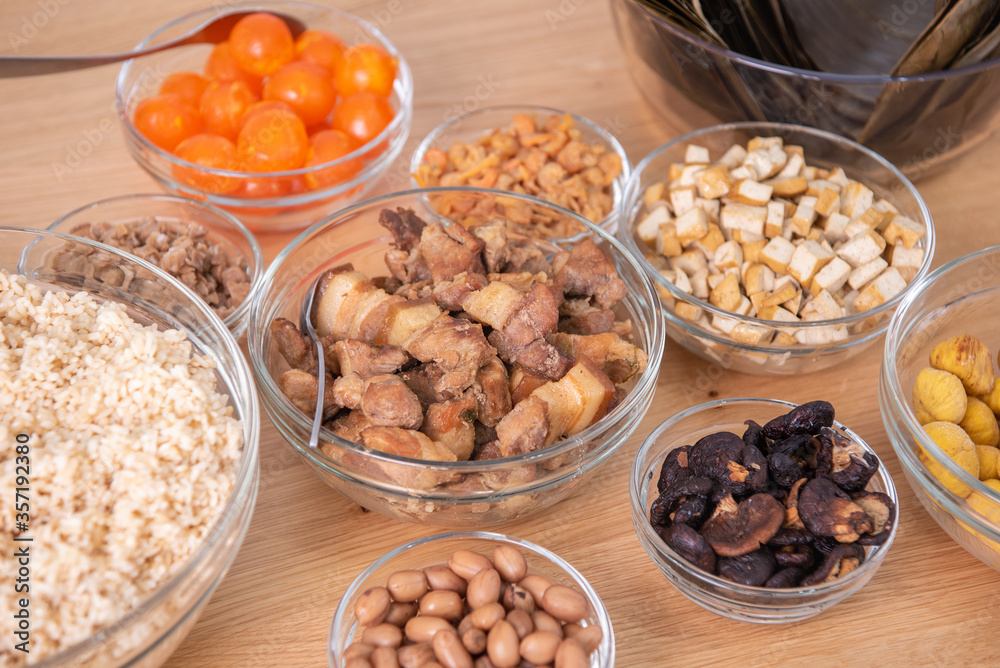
(629, 398), (899, 624)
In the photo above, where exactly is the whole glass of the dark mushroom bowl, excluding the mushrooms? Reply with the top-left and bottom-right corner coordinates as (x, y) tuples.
(629, 398), (899, 624)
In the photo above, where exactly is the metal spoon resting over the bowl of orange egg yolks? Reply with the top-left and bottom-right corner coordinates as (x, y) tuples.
(0, 11), (306, 79)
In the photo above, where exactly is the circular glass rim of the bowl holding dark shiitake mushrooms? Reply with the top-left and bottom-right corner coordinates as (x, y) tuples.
(629, 397), (900, 605)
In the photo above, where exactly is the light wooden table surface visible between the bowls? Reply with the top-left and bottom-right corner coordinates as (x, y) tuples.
(0, 0), (1000, 668)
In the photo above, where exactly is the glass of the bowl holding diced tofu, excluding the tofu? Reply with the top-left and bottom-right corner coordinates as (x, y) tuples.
(618, 123), (935, 375)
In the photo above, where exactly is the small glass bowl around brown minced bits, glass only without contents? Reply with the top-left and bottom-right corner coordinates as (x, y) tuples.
(48, 195), (264, 340)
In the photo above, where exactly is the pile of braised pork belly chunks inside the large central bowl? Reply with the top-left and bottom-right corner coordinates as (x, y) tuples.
(271, 209), (647, 478)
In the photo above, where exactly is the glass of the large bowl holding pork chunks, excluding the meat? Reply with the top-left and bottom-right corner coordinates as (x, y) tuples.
(247, 188), (663, 527)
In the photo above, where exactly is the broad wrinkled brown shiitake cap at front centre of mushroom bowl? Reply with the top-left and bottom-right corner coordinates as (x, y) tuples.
(701, 494), (784, 557)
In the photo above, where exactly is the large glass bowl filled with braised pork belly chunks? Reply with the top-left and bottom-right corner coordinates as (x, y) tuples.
(248, 188), (664, 527)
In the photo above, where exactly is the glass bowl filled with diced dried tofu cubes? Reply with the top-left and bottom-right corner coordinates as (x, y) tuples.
(619, 123), (934, 374)
